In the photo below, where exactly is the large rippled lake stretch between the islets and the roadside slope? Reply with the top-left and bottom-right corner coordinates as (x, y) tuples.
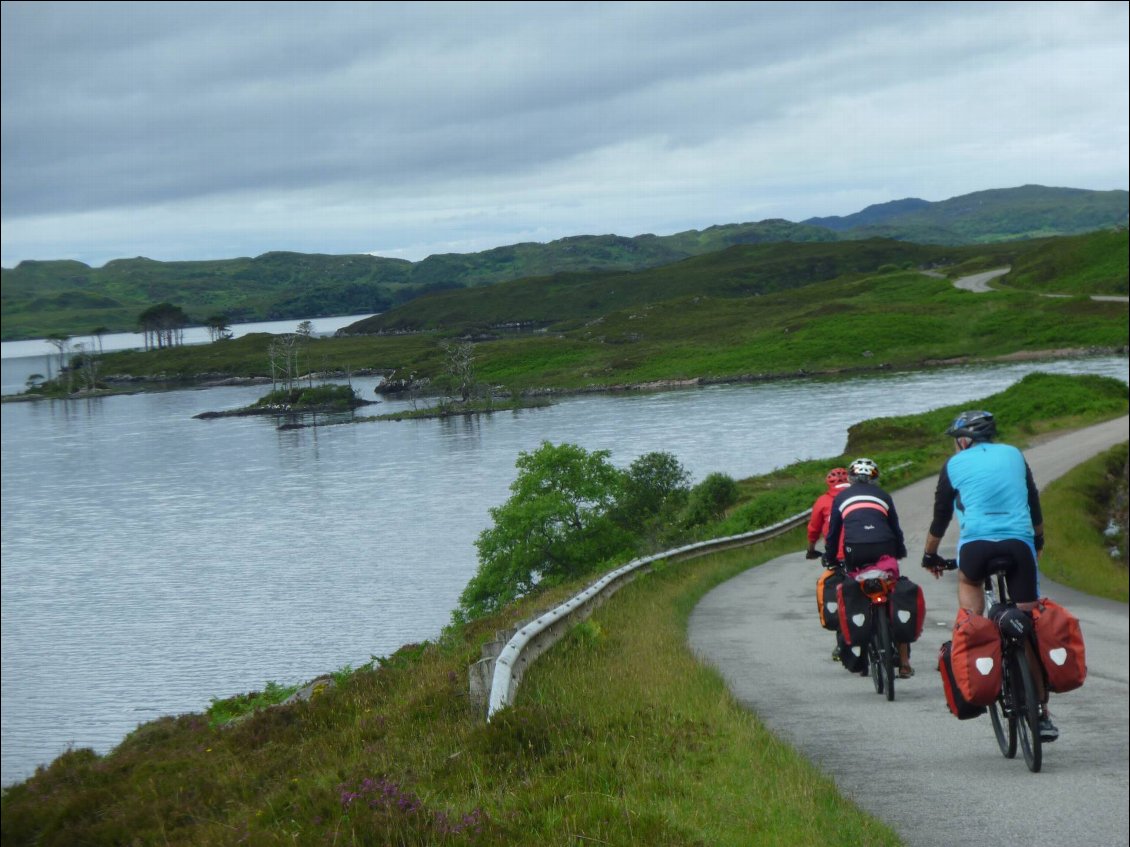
(0, 357), (1127, 785)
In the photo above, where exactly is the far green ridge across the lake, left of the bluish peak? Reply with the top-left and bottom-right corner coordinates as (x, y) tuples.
(0, 221), (836, 341)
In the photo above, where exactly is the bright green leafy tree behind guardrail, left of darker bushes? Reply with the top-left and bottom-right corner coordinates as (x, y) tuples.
(457, 442), (635, 619)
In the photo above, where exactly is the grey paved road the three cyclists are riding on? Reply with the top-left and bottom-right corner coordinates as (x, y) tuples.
(689, 418), (1130, 847)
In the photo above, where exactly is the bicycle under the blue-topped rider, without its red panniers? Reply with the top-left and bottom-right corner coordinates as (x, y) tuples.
(938, 557), (1043, 774)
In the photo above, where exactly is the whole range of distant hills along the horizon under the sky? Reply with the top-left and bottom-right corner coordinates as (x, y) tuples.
(0, 185), (1130, 340)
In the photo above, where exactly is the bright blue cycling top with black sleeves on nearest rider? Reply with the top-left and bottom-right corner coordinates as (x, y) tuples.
(930, 442), (1044, 544)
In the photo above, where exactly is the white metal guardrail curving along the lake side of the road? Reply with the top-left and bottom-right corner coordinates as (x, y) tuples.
(468, 510), (811, 721)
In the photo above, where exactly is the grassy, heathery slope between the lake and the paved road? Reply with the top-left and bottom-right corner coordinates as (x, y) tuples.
(0, 375), (1128, 846)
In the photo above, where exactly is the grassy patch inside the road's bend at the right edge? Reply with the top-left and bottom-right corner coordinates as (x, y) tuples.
(1040, 444), (1130, 603)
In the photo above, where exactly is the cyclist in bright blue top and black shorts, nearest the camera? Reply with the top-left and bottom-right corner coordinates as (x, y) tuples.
(922, 410), (1059, 741)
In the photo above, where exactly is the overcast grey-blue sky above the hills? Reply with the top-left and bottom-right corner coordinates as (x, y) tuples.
(0, 0), (1130, 268)
